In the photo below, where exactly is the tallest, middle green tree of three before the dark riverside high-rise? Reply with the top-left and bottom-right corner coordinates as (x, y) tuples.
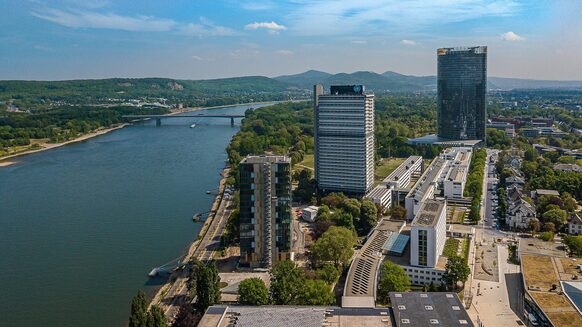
(269, 260), (305, 305)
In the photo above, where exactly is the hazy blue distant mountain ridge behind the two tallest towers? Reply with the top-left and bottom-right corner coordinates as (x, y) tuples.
(274, 70), (582, 93)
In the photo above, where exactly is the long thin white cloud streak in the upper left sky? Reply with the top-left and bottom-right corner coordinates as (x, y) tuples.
(31, 8), (176, 32)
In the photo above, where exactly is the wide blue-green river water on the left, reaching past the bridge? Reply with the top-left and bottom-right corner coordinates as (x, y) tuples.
(0, 106), (256, 327)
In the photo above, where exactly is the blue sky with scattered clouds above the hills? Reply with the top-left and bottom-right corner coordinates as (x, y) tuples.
(0, 0), (582, 80)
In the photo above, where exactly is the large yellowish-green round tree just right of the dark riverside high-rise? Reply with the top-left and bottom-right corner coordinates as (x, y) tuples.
(311, 226), (356, 267)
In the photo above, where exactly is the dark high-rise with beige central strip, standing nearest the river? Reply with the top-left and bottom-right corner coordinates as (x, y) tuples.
(239, 156), (293, 268)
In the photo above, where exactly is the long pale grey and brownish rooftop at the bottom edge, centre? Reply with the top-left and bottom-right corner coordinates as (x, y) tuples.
(198, 305), (392, 327)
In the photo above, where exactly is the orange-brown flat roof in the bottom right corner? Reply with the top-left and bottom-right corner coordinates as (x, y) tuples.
(520, 255), (582, 327)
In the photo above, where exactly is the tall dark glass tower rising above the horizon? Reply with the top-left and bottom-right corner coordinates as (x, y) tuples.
(437, 46), (487, 140)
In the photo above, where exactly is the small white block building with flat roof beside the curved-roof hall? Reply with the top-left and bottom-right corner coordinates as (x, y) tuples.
(410, 199), (447, 268)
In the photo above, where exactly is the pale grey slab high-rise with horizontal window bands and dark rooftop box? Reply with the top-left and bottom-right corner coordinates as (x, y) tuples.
(314, 85), (374, 195)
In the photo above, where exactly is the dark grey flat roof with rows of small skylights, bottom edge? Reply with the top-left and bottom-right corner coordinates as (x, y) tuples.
(390, 292), (475, 327)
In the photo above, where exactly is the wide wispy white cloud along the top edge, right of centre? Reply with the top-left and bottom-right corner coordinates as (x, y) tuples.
(285, 0), (522, 35)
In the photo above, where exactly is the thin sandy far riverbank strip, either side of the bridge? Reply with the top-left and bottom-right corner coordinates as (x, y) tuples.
(0, 101), (285, 167)
